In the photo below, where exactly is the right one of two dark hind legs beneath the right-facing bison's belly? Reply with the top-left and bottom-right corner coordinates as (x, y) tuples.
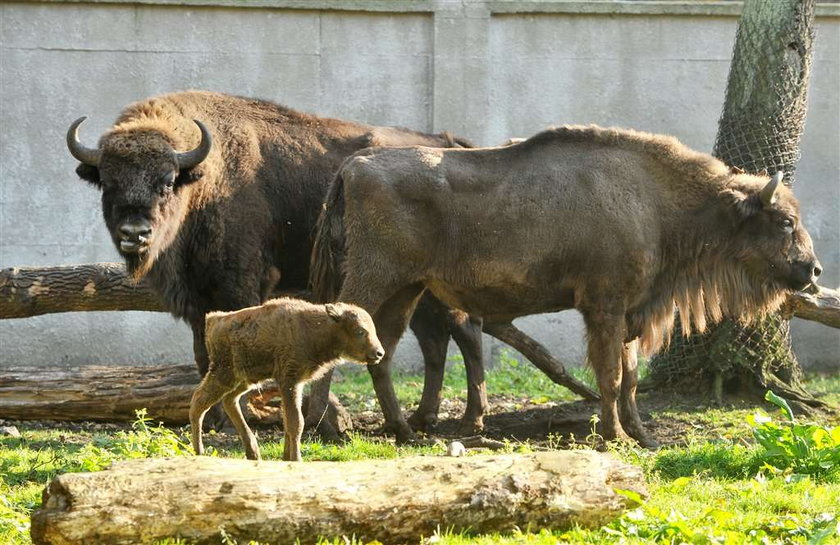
(447, 309), (488, 435)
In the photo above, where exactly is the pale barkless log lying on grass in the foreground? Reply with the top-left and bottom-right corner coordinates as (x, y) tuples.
(32, 451), (646, 545)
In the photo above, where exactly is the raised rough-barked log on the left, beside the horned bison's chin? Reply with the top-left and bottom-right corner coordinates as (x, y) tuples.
(0, 263), (166, 318)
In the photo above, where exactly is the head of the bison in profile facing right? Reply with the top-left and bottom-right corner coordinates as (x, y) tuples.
(730, 172), (822, 290)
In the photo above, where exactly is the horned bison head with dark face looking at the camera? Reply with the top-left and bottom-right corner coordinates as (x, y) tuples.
(67, 117), (212, 275)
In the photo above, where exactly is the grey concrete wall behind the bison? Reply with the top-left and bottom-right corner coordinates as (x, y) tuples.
(0, 0), (840, 369)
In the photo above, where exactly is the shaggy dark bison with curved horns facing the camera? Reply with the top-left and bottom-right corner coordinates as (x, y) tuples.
(67, 91), (486, 434)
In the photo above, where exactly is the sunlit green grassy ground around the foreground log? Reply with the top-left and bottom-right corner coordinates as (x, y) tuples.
(0, 360), (840, 545)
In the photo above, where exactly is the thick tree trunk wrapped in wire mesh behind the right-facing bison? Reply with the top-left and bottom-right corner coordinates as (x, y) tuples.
(651, 0), (823, 407)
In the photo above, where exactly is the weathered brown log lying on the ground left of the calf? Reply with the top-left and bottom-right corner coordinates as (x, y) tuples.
(0, 365), (199, 424)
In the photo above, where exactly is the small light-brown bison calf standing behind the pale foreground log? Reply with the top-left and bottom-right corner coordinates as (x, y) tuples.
(190, 298), (385, 461)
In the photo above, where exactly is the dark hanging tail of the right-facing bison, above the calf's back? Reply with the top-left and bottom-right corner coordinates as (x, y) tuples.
(309, 169), (345, 303)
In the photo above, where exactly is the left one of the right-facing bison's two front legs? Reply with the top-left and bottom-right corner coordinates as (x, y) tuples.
(583, 310), (629, 440)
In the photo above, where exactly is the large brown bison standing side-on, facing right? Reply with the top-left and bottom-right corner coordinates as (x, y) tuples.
(312, 126), (820, 445)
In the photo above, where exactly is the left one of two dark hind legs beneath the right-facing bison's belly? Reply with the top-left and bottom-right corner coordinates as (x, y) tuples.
(408, 294), (449, 432)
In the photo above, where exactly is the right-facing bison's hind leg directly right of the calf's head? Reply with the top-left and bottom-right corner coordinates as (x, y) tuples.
(368, 284), (423, 444)
